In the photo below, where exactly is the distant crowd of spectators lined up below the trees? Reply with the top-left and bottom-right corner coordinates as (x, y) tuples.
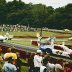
(0, 24), (43, 32)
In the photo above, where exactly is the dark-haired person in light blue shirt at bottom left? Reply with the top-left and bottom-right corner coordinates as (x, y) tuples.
(3, 57), (17, 72)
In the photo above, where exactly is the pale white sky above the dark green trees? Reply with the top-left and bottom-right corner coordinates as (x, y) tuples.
(6, 0), (72, 8)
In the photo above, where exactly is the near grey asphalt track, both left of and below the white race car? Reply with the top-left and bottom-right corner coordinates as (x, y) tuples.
(0, 42), (72, 61)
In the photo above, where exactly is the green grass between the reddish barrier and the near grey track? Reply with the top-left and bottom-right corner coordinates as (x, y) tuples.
(7, 38), (72, 47)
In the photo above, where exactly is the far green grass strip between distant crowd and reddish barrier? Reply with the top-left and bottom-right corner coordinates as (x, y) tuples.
(0, 31), (72, 37)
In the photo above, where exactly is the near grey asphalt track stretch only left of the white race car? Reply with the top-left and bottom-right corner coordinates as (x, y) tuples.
(0, 42), (38, 52)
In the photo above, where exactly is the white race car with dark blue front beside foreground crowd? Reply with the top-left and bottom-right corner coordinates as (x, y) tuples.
(39, 44), (72, 57)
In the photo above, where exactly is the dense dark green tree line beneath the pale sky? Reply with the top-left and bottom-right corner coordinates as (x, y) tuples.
(0, 0), (72, 29)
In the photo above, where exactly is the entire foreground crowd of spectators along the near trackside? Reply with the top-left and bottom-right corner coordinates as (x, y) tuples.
(0, 48), (72, 72)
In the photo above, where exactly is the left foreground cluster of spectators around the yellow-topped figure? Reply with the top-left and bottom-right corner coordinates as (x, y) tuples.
(0, 48), (25, 72)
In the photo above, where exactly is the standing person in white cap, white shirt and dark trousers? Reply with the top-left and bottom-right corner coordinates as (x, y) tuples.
(34, 50), (43, 72)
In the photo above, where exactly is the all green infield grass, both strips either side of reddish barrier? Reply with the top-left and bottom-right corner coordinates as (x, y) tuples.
(0, 31), (72, 47)
